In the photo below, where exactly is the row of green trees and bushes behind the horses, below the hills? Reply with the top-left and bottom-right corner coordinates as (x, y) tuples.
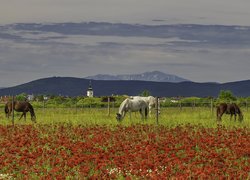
(0, 90), (250, 108)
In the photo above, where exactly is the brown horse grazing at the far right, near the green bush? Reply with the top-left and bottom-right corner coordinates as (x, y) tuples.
(217, 103), (243, 121)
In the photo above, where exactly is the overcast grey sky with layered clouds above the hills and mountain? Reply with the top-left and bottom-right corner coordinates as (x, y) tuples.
(0, 0), (250, 87)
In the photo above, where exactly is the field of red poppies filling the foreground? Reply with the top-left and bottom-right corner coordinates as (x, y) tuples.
(0, 124), (250, 179)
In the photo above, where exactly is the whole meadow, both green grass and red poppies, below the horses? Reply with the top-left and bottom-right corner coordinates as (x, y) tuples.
(0, 107), (250, 179)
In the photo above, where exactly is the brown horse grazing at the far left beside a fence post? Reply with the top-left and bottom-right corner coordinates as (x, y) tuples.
(4, 101), (36, 122)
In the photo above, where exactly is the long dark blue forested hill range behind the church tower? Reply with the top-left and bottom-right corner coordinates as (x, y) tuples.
(0, 77), (250, 97)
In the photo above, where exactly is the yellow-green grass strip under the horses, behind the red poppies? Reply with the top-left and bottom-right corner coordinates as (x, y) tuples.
(0, 107), (250, 127)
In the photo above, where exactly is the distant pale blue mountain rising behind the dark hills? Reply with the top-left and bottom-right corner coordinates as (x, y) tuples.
(85, 71), (190, 83)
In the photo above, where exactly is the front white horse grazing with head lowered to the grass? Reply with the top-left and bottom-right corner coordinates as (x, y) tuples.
(116, 98), (148, 121)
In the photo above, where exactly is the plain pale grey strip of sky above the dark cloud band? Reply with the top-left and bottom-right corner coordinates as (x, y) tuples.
(0, 0), (250, 26)
